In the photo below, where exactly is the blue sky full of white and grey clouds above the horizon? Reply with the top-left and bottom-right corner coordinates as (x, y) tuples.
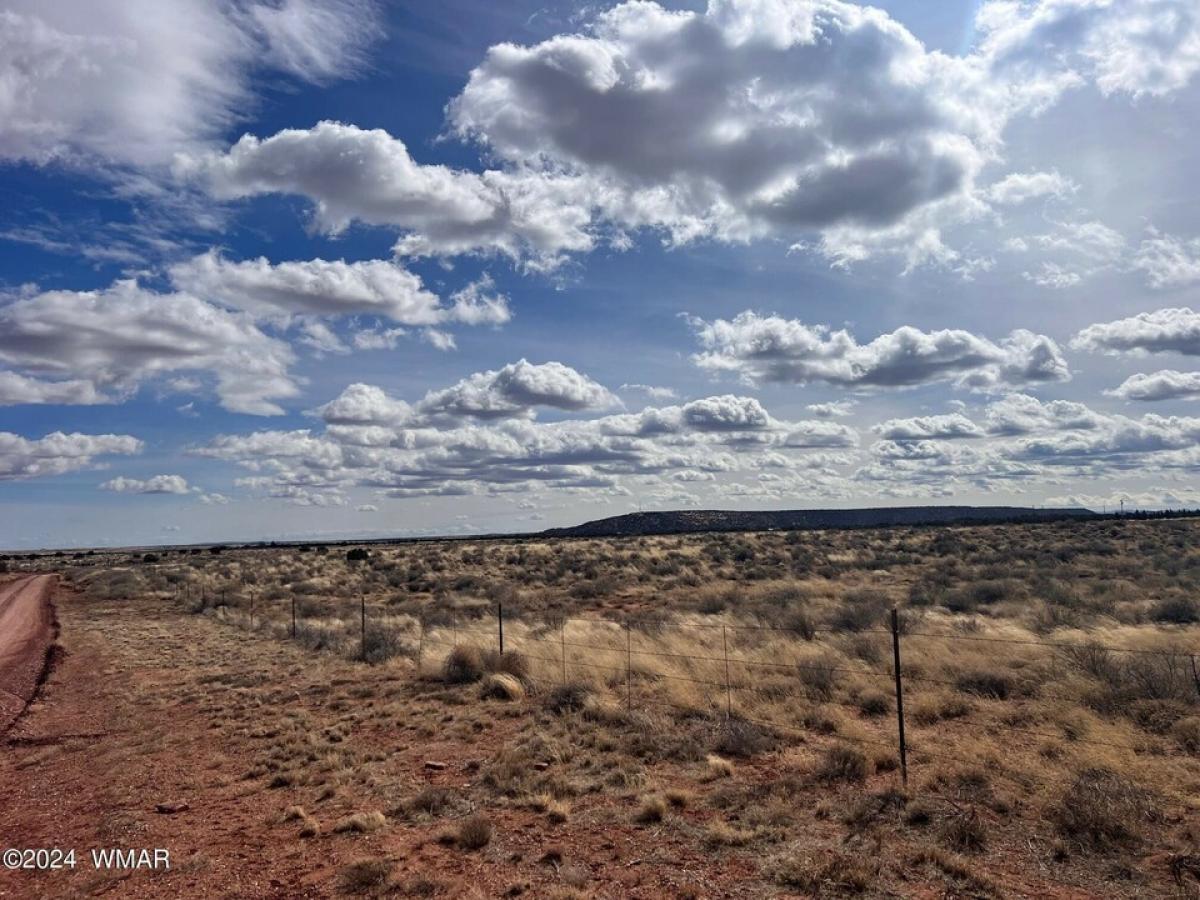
(0, 0), (1200, 548)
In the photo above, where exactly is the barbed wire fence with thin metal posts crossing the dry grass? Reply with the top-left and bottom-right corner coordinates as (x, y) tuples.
(175, 584), (1200, 785)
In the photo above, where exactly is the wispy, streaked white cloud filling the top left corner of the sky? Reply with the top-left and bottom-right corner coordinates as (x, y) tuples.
(0, 0), (378, 169)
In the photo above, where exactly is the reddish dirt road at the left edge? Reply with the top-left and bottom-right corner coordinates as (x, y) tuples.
(0, 575), (54, 734)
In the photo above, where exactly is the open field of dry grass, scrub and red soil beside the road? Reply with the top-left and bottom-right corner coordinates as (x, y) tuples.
(0, 520), (1200, 898)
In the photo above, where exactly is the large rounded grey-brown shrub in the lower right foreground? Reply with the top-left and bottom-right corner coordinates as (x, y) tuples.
(1050, 768), (1157, 848)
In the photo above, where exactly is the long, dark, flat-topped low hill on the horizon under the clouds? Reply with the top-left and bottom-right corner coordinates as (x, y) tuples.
(542, 506), (1096, 538)
